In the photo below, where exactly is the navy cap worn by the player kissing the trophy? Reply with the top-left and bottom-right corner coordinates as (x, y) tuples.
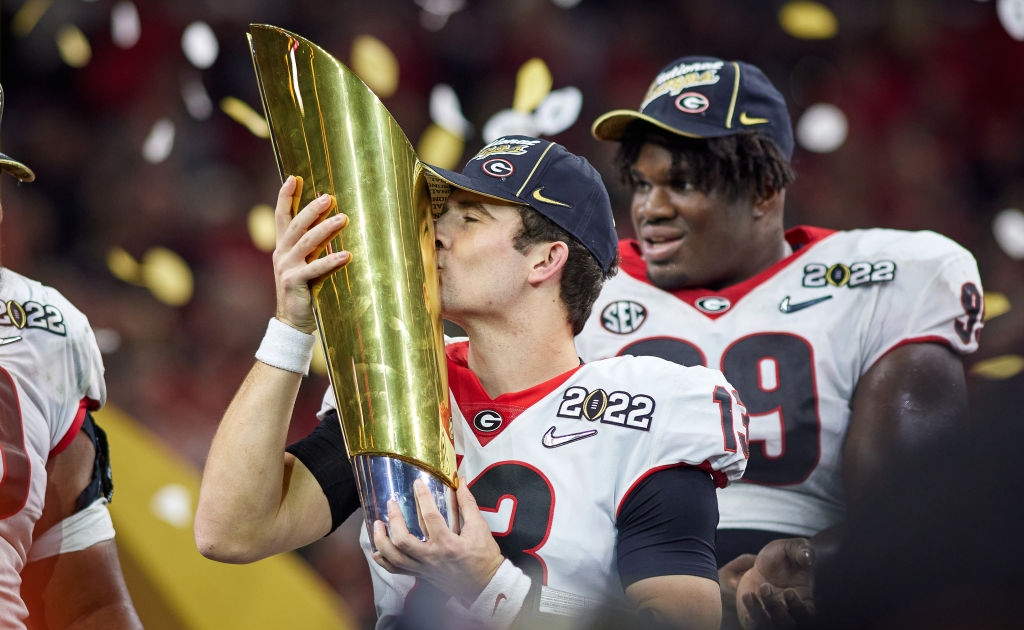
(424, 135), (618, 271)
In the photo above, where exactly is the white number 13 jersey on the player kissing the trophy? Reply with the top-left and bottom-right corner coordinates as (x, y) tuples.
(348, 343), (746, 628)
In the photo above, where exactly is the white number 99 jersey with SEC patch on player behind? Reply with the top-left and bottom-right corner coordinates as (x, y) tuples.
(577, 227), (983, 536)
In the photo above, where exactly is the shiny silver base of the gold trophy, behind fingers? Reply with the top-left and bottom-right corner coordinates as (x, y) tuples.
(352, 455), (459, 551)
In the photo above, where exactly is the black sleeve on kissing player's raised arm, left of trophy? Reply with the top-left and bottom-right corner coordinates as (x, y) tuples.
(286, 411), (360, 532)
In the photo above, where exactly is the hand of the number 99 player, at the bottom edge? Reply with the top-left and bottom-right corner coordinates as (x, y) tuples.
(736, 538), (814, 630)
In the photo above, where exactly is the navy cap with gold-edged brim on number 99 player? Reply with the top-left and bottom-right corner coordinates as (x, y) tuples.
(591, 56), (794, 160)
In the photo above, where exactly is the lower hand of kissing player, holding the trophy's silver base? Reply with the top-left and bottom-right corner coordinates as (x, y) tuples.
(374, 479), (505, 604)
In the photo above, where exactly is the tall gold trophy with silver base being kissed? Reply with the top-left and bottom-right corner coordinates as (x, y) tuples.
(248, 25), (459, 543)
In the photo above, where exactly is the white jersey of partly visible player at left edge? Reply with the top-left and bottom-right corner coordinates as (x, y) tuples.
(0, 267), (106, 628)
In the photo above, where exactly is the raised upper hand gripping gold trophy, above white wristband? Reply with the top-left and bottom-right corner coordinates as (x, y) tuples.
(273, 175), (351, 333)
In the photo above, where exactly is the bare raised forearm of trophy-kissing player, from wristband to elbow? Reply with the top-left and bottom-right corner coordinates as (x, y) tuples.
(195, 362), (302, 562)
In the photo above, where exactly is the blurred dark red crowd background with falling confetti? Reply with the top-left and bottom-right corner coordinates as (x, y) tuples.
(0, 0), (1024, 620)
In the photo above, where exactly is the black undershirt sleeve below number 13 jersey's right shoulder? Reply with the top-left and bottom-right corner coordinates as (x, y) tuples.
(615, 466), (718, 589)
